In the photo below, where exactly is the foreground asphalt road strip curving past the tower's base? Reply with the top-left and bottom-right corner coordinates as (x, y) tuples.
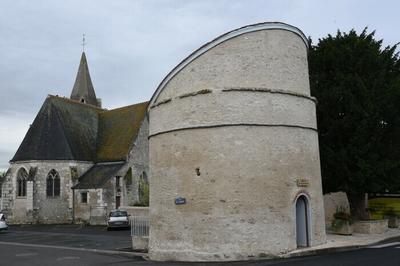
(0, 242), (400, 266)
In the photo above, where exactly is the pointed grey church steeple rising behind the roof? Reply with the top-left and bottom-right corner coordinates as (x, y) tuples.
(71, 52), (99, 106)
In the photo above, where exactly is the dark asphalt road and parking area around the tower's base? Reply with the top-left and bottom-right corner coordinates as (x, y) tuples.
(0, 226), (400, 266)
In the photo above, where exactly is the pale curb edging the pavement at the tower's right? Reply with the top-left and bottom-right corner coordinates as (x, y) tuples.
(279, 235), (400, 259)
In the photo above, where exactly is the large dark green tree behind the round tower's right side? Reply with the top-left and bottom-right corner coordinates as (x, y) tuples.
(309, 28), (400, 219)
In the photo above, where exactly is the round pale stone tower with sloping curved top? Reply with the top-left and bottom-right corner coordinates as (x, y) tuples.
(149, 23), (325, 261)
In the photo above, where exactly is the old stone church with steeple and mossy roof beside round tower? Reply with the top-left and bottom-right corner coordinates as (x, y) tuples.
(1, 52), (149, 224)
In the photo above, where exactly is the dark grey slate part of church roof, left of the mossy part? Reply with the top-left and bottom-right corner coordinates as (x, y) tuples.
(11, 96), (101, 162)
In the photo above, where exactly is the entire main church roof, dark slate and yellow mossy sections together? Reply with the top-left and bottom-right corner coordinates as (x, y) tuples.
(11, 96), (148, 162)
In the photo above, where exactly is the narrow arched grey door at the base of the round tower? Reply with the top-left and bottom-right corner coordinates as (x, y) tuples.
(296, 195), (309, 247)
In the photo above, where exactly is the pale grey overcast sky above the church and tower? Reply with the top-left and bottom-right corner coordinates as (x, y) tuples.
(0, 0), (400, 170)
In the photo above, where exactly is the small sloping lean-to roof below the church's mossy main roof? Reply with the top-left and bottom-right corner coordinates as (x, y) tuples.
(73, 162), (125, 189)
